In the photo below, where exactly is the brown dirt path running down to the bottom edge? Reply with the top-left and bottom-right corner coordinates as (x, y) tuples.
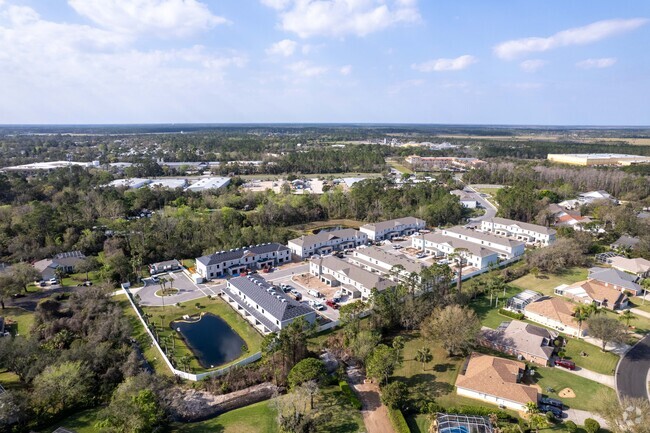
(347, 368), (395, 433)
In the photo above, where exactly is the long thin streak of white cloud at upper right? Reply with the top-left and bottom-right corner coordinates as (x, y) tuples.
(494, 18), (648, 60)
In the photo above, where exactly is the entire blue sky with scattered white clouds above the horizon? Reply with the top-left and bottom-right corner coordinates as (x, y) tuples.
(0, 0), (650, 125)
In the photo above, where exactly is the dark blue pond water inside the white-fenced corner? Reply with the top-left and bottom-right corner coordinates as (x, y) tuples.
(171, 313), (245, 368)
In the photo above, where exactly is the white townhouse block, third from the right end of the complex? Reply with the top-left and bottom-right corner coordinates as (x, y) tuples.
(411, 232), (500, 269)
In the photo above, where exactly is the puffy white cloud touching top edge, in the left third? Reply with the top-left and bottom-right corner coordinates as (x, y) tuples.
(68, 0), (227, 37)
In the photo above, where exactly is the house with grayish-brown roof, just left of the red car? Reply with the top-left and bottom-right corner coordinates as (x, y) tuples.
(479, 320), (558, 366)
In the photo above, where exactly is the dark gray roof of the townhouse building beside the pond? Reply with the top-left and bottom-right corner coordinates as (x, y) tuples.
(228, 275), (313, 322)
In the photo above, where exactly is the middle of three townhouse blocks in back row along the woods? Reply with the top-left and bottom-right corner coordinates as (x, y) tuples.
(287, 229), (368, 259)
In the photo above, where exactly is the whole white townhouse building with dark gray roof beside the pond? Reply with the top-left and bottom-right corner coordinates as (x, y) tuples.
(221, 275), (316, 334)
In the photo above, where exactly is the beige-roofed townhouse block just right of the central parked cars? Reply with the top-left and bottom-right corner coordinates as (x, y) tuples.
(309, 256), (396, 299)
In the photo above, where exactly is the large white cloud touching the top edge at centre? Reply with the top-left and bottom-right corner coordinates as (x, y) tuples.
(262, 0), (420, 38)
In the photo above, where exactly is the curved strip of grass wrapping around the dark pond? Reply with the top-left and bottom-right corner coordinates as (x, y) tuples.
(140, 298), (262, 372)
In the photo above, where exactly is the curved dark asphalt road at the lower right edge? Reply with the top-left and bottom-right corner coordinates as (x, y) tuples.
(616, 335), (650, 399)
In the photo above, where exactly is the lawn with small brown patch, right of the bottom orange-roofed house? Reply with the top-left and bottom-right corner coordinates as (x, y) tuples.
(535, 367), (616, 411)
